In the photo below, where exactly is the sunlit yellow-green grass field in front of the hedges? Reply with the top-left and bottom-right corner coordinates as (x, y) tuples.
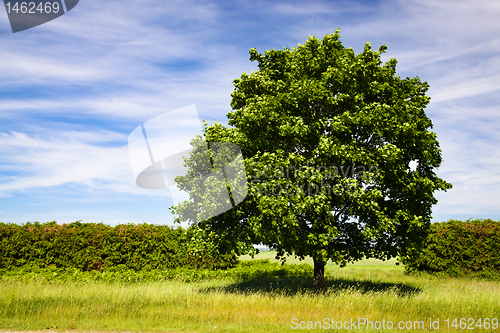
(0, 252), (500, 333)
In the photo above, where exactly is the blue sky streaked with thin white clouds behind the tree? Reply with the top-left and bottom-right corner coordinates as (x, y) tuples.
(0, 0), (500, 225)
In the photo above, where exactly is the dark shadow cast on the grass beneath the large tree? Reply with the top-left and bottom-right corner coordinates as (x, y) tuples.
(200, 277), (422, 297)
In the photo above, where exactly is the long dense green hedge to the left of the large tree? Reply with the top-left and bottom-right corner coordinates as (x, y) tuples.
(0, 221), (237, 271)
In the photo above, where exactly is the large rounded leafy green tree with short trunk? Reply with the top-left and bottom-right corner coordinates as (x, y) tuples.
(171, 30), (451, 287)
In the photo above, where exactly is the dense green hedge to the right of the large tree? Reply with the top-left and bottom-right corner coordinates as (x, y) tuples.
(403, 219), (500, 277)
